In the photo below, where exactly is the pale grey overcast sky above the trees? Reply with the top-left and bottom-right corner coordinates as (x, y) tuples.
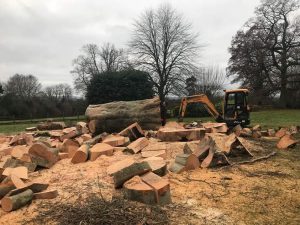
(0, 0), (260, 88)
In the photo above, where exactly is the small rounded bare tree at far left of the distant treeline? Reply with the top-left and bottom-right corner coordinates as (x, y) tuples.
(4, 74), (42, 100)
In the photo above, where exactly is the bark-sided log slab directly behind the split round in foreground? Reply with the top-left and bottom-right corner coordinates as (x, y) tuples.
(112, 160), (151, 188)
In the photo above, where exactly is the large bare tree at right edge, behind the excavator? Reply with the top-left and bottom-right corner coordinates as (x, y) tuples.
(228, 0), (300, 107)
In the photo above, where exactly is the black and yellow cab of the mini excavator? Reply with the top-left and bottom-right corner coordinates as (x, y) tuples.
(223, 89), (250, 126)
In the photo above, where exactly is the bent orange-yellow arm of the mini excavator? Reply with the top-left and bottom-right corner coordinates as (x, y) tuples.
(178, 94), (221, 121)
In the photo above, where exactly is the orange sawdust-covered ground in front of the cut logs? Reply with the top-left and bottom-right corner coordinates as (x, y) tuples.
(0, 136), (300, 225)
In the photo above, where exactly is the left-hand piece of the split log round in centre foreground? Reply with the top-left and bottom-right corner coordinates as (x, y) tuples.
(123, 176), (157, 204)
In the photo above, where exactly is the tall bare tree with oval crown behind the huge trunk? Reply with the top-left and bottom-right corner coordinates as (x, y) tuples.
(130, 5), (199, 123)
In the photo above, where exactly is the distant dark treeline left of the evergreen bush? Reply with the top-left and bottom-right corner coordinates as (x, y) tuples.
(0, 74), (87, 120)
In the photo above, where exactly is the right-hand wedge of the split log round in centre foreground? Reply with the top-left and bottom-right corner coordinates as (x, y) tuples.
(141, 172), (171, 204)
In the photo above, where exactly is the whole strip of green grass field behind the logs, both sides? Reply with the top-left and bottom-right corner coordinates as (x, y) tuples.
(0, 109), (300, 134)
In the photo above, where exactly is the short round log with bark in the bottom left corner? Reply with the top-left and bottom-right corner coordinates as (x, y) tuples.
(1, 189), (33, 212)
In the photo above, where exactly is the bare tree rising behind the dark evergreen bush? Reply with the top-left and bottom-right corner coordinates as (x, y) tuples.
(71, 43), (129, 93)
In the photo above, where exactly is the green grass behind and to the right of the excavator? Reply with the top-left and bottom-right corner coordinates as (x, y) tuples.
(170, 109), (300, 128)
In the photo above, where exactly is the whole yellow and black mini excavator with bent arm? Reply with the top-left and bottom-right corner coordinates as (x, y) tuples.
(178, 89), (250, 127)
